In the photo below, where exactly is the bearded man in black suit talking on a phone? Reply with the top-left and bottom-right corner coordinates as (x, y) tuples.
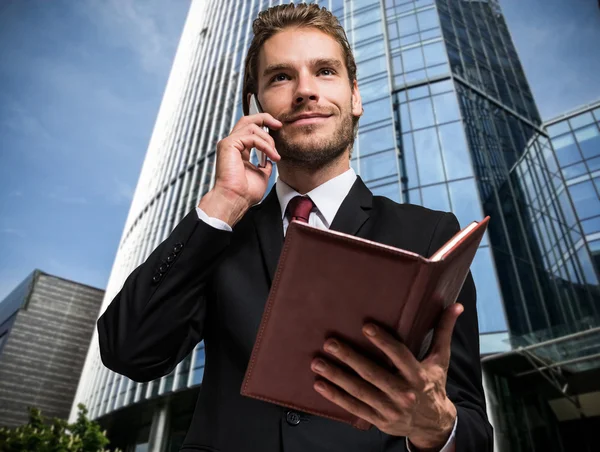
(98, 4), (492, 452)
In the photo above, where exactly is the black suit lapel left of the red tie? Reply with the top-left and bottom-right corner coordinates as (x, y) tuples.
(254, 185), (283, 282)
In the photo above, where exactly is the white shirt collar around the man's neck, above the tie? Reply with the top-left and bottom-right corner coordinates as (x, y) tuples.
(275, 168), (356, 227)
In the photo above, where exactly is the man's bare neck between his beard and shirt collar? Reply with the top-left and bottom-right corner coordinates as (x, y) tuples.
(277, 152), (350, 195)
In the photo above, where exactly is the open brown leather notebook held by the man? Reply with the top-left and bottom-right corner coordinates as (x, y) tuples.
(241, 217), (489, 430)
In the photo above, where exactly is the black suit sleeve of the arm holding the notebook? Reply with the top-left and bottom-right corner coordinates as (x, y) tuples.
(428, 213), (493, 452)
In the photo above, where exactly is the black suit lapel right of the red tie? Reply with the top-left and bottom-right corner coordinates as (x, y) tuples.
(330, 176), (373, 235)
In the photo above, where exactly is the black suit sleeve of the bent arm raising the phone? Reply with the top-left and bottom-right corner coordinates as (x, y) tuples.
(97, 210), (232, 382)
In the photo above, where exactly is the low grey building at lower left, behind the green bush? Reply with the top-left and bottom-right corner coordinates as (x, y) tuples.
(0, 270), (104, 427)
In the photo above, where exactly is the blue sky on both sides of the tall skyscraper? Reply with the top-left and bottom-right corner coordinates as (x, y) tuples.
(0, 0), (600, 300)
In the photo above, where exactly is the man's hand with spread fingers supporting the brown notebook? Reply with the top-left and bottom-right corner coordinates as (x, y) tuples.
(311, 303), (464, 450)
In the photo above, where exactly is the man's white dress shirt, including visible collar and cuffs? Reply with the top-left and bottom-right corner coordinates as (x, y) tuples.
(196, 168), (458, 452)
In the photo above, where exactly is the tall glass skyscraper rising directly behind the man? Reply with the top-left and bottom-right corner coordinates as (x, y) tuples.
(72, 0), (598, 450)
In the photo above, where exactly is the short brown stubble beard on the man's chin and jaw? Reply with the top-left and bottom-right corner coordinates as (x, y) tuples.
(273, 113), (354, 171)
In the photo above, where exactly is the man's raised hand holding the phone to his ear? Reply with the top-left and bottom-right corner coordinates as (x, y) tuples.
(198, 113), (282, 227)
